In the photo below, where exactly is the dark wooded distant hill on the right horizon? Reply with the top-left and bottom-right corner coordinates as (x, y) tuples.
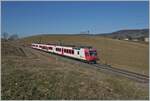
(97, 29), (149, 39)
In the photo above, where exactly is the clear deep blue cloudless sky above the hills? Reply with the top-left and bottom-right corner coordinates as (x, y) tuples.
(1, 1), (149, 36)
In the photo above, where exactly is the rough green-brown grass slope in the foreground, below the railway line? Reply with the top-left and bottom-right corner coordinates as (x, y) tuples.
(1, 40), (149, 100)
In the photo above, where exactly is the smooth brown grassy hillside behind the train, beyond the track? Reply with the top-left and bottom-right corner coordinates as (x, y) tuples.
(21, 36), (149, 74)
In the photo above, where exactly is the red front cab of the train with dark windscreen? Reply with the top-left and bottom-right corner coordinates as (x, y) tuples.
(85, 49), (97, 64)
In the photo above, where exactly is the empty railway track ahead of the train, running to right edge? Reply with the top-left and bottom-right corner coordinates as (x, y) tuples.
(92, 64), (149, 83)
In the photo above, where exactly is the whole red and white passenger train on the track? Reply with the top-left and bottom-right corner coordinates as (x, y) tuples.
(31, 43), (97, 63)
